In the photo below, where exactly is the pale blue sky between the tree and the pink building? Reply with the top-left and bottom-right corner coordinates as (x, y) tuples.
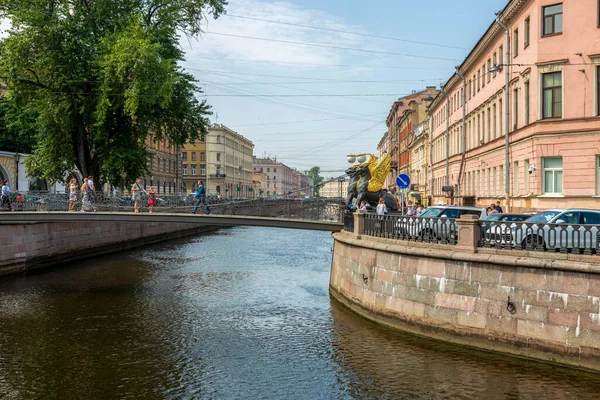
(182, 0), (507, 176)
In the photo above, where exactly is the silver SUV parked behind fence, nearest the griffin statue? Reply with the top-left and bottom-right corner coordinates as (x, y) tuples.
(398, 205), (487, 240)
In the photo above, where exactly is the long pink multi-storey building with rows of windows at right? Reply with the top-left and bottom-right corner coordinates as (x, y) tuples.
(430, 0), (600, 212)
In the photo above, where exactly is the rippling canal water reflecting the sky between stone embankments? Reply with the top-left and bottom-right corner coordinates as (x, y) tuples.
(0, 228), (600, 400)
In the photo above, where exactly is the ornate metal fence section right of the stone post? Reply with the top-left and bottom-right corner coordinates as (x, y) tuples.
(480, 221), (600, 255)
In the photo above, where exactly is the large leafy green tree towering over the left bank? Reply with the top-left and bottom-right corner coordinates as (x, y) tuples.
(0, 0), (227, 186)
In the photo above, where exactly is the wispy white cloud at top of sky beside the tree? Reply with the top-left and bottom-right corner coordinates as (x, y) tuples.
(184, 0), (368, 64)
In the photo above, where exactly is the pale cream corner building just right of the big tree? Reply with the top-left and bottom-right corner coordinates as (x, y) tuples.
(205, 124), (254, 198)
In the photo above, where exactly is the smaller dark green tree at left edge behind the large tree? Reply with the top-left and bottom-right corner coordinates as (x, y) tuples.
(0, 96), (35, 153)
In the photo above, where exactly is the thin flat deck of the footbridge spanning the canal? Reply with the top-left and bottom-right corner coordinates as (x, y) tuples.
(0, 211), (343, 232)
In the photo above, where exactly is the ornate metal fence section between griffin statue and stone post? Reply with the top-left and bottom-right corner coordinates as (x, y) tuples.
(364, 214), (458, 245)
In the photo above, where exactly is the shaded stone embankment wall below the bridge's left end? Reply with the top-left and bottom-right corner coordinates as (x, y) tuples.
(0, 222), (215, 275)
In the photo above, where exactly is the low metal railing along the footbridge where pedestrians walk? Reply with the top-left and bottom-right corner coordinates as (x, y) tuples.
(0, 192), (343, 222)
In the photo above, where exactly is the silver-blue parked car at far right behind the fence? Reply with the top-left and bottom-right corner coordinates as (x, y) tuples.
(501, 209), (600, 251)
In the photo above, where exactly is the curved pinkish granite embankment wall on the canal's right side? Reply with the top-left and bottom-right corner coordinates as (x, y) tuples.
(330, 225), (600, 371)
